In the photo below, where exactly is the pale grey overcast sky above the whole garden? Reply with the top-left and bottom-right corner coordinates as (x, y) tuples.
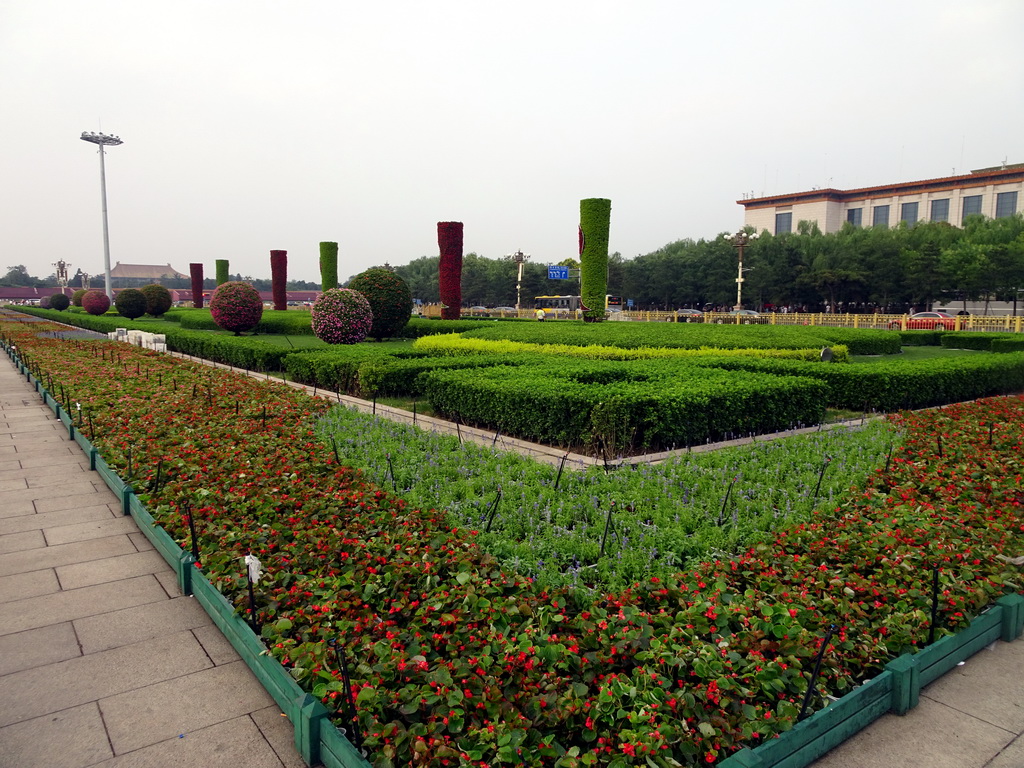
(0, 0), (1024, 285)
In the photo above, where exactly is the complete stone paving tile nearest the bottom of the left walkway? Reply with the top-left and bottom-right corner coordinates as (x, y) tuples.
(99, 660), (273, 755)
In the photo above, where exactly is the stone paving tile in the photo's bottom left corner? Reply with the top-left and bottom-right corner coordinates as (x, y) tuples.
(0, 701), (114, 768)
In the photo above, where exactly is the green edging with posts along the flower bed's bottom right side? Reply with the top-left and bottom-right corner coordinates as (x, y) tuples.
(720, 594), (1024, 768)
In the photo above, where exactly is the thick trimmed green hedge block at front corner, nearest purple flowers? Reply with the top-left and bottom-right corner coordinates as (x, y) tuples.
(420, 359), (826, 454)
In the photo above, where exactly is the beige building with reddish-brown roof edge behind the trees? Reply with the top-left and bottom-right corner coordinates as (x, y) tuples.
(736, 163), (1024, 234)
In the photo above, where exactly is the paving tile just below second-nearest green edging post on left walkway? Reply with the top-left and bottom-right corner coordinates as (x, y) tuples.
(74, 593), (211, 653)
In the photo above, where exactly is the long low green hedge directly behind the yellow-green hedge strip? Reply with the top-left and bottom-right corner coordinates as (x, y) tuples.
(460, 322), (900, 354)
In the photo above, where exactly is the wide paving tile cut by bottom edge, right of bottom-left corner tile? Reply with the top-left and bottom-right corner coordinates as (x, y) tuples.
(91, 715), (282, 768)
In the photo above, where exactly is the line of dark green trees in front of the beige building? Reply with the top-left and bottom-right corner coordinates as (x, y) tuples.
(395, 214), (1024, 312)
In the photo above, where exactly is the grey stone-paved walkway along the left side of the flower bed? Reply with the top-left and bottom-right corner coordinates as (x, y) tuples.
(0, 356), (304, 768)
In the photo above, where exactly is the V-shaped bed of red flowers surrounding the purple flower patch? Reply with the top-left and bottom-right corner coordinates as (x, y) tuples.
(8, 313), (1024, 768)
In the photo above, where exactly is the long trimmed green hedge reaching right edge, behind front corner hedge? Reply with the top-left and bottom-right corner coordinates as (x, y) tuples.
(692, 352), (1024, 412)
